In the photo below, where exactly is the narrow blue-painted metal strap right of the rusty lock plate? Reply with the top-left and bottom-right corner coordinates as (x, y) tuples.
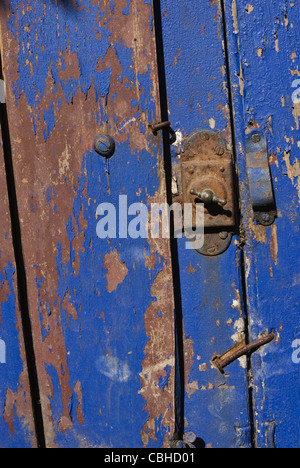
(246, 130), (277, 226)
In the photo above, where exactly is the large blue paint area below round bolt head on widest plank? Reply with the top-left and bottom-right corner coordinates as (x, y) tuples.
(51, 145), (169, 447)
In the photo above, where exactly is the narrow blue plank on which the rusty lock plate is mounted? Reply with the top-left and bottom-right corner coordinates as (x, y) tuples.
(161, 0), (250, 448)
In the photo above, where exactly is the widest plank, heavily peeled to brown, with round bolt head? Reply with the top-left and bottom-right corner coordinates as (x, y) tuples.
(1, 0), (174, 447)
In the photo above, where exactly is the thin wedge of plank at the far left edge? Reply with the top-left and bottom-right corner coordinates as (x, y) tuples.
(0, 114), (36, 448)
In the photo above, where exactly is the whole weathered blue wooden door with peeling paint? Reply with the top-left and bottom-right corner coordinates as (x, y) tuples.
(0, 0), (300, 448)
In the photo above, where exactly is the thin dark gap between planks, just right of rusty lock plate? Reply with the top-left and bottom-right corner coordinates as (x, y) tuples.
(220, 0), (256, 448)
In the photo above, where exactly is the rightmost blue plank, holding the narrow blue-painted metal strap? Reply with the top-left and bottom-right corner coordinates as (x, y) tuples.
(225, 0), (300, 448)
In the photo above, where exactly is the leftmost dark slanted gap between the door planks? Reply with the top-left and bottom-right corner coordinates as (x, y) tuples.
(0, 55), (46, 448)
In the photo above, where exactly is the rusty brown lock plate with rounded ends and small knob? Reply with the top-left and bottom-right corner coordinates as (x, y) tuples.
(180, 130), (235, 256)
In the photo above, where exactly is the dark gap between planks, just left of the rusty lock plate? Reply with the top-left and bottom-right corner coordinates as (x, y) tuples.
(153, 0), (185, 443)
